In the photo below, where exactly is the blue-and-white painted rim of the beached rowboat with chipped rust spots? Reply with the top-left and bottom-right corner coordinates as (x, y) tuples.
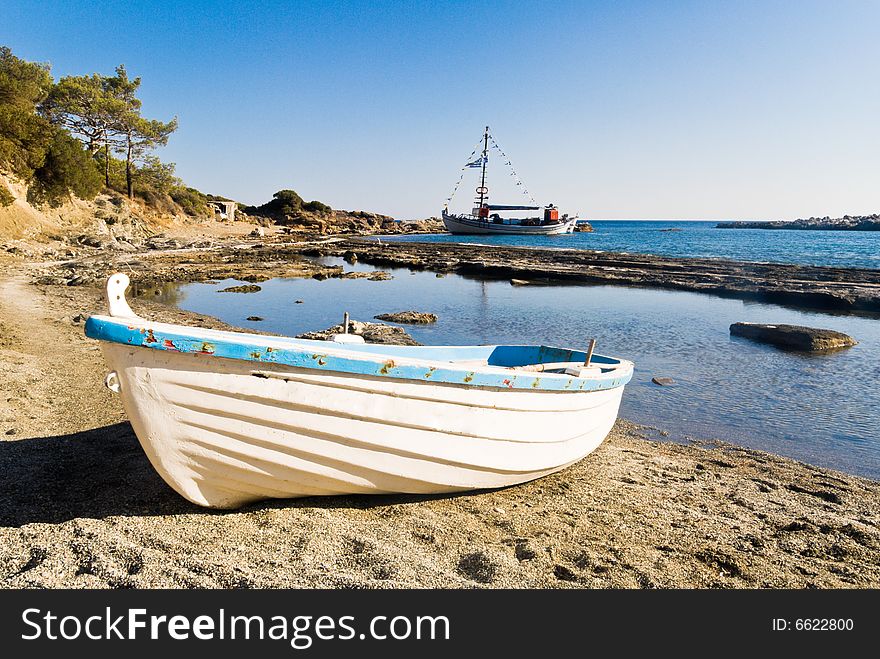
(85, 316), (632, 391)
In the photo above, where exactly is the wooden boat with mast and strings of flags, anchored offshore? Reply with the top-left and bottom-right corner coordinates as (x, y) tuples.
(442, 126), (578, 236)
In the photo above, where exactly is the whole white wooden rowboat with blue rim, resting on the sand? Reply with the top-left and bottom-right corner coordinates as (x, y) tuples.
(85, 273), (633, 508)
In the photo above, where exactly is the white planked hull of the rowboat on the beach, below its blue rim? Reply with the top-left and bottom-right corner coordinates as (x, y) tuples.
(101, 341), (623, 508)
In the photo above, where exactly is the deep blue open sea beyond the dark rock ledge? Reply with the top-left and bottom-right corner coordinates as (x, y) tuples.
(390, 220), (880, 268)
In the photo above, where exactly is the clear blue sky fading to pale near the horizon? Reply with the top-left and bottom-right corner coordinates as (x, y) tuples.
(0, 0), (880, 218)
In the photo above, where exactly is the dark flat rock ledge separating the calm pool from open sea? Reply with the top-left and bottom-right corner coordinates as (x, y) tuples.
(300, 239), (880, 312)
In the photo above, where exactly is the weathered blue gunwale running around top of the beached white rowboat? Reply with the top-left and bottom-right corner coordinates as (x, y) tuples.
(85, 315), (633, 393)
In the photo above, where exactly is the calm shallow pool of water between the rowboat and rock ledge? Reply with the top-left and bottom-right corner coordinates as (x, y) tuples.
(156, 259), (880, 478)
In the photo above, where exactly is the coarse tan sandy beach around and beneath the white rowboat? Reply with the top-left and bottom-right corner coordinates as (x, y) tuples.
(0, 244), (880, 588)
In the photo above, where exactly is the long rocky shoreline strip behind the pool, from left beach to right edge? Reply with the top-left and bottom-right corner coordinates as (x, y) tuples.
(17, 231), (880, 313)
